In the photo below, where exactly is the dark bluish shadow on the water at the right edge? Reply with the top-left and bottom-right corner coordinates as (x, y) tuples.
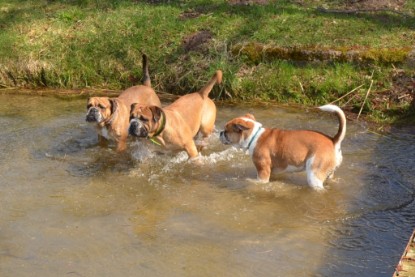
(318, 129), (415, 277)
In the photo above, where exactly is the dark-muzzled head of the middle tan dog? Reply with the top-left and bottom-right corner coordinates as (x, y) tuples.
(128, 104), (163, 138)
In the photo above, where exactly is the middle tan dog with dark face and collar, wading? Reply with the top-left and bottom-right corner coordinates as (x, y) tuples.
(129, 70), (222, 158)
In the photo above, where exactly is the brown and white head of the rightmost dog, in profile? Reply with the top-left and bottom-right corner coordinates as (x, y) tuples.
(220, 114), (262, 146)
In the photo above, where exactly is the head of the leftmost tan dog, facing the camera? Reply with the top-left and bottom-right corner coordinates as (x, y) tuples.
(86, 97), (117, 124)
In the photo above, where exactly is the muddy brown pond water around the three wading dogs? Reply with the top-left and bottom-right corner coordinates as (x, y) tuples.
(0, 95), (415, 276)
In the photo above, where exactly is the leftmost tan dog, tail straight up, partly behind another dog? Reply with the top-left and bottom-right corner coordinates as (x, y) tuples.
(86, 55), (161, 151)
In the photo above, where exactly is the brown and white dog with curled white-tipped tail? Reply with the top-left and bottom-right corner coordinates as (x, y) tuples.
(220, 105), (346, 189)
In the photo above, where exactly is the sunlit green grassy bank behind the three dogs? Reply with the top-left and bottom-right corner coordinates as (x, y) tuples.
(0, 0), (415, 122)
